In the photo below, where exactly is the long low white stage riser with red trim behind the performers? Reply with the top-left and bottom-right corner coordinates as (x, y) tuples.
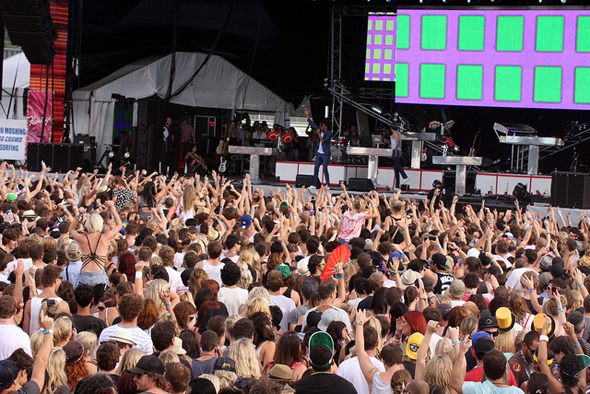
(275, 161), (551, 197)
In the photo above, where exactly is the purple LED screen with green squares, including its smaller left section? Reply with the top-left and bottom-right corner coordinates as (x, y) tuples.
(365, 9), (590, 109)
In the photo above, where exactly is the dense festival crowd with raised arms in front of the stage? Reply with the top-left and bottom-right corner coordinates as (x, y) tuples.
(0, 162), (590, 394)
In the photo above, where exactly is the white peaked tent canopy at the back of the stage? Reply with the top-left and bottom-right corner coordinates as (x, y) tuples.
(73, 52), (293, 159)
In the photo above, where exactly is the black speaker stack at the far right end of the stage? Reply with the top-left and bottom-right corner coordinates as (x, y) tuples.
(551, 172), (590, 209)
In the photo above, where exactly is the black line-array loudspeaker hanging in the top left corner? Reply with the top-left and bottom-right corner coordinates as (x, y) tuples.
(1, 0), (57, 65)
